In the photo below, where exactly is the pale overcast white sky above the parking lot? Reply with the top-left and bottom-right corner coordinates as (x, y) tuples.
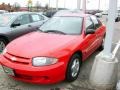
(0, 0), (120, 10)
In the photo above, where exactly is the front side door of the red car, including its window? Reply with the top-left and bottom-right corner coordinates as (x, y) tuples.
(83, 17), (99, 58)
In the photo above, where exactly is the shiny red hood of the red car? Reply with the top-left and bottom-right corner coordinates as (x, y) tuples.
(7, 32), (78, 58)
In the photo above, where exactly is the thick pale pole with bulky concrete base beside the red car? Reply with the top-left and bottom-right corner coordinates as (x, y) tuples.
(90, 0), (118, 90)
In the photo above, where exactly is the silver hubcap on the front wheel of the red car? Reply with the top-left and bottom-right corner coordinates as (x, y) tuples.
(71, 59), (80, 77)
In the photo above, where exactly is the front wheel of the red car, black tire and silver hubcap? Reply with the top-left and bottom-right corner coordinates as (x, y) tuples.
(66, 54), (82, 82)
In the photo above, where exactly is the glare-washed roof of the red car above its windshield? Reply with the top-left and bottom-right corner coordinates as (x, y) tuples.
(54, 10), (91, 17)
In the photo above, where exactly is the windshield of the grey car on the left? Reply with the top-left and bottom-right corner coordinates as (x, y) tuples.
(0, 14), (15, 26)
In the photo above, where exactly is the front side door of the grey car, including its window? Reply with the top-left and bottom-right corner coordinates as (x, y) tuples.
(9, 14), (34, 39)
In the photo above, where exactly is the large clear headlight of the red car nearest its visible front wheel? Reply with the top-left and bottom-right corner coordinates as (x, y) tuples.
(32, 57), (58, 66)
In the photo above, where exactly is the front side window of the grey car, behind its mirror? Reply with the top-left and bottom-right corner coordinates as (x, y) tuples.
(14, 14), (30, 25)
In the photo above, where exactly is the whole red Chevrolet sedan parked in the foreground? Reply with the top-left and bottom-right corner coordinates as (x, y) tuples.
(0, 11), (106, 84)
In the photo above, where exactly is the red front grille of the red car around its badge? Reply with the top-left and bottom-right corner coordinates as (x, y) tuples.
(4, 53), (30, 64)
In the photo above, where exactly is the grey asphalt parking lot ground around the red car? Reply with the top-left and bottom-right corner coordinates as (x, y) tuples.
(0, 15), (120, 90)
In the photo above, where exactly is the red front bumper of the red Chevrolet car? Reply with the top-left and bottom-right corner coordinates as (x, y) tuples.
(0, 56), (66, 84)
